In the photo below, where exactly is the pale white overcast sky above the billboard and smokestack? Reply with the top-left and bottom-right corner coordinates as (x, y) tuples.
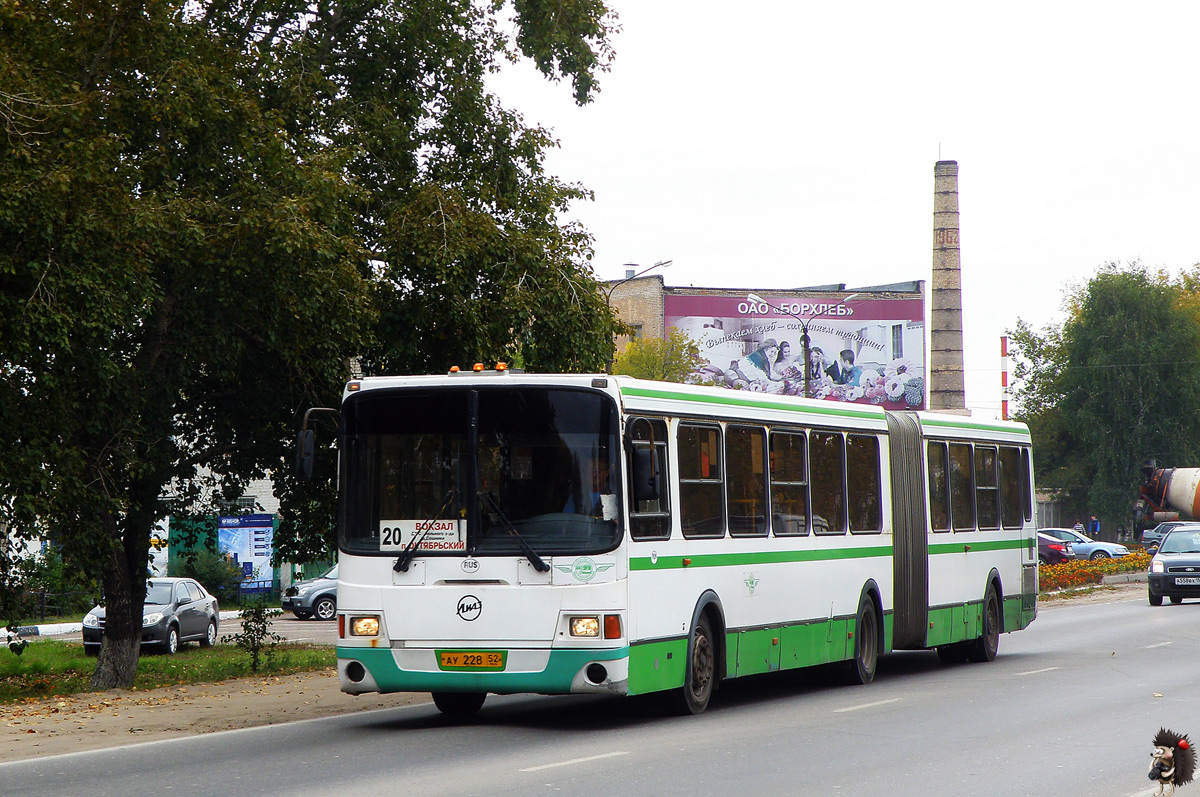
(494, 0), (1200, 418)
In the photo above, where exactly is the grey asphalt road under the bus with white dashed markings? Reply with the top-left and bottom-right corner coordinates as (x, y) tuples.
(9, 595), (1200, 797)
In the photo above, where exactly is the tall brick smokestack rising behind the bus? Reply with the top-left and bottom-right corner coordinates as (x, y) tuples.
(929, 161), (967, 413)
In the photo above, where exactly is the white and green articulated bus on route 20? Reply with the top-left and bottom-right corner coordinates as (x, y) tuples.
(301, 370), (1038, 714)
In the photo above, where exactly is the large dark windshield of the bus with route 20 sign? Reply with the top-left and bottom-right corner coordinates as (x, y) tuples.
(340, 385), (622, 556)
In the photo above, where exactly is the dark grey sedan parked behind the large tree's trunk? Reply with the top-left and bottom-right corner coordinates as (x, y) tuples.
(83, 579), (221, 655)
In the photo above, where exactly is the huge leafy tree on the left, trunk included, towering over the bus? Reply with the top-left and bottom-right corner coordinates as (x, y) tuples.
(0, 0), (616, 688)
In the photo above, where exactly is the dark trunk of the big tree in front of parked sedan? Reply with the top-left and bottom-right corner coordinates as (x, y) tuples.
(89, 525), (145, 690)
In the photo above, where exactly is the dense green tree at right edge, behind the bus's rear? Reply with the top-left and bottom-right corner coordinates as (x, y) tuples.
(1013, 263), (1200, 521)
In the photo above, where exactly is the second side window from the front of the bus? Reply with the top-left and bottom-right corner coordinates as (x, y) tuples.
(678, 424), (725, 537)
